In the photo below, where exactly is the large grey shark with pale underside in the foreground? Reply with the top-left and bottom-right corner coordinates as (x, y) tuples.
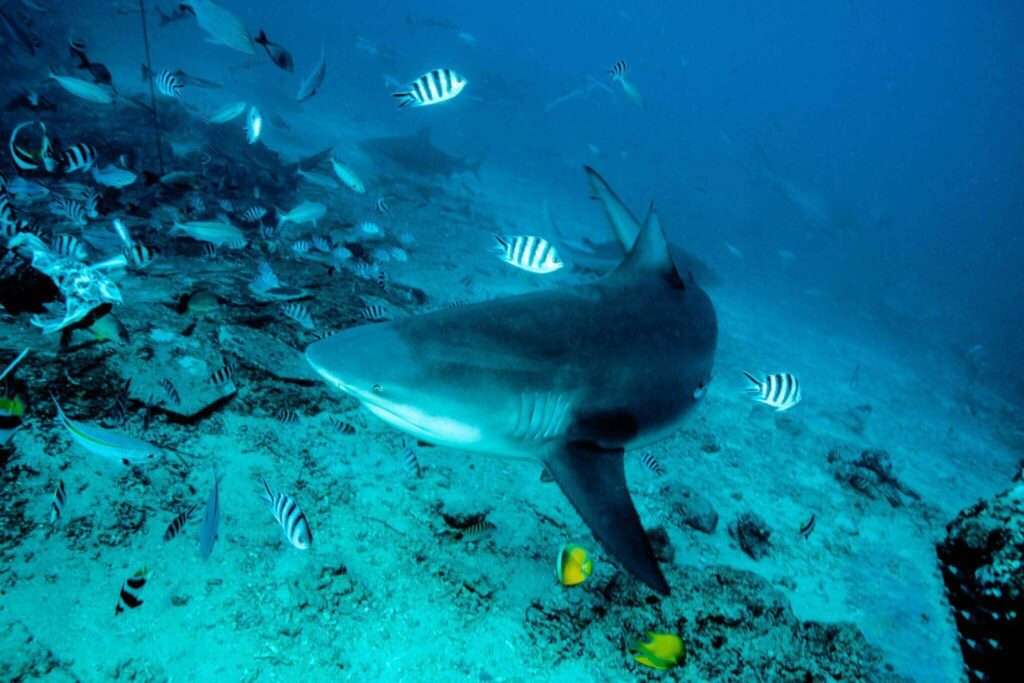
(305, 166), (718, 595)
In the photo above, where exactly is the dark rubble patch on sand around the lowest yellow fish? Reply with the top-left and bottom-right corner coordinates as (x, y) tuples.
(523, 566), (906, 683)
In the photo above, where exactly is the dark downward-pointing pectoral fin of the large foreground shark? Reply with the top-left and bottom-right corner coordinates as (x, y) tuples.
(544, 442), (669, 595)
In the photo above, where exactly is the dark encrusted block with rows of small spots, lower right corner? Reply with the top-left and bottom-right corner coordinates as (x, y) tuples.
(937, 481), (1024, 681)
